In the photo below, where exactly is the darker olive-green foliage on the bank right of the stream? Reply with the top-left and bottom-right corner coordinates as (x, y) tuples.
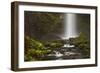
(71, 33), (90, 57)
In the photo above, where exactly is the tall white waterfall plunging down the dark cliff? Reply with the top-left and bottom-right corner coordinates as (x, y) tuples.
(62, 13), (78, 39)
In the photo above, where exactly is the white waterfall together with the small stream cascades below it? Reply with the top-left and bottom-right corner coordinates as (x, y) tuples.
(56, 13), (78, 57)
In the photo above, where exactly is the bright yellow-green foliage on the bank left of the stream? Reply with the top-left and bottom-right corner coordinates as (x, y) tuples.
(25, 36), (50, 61)
